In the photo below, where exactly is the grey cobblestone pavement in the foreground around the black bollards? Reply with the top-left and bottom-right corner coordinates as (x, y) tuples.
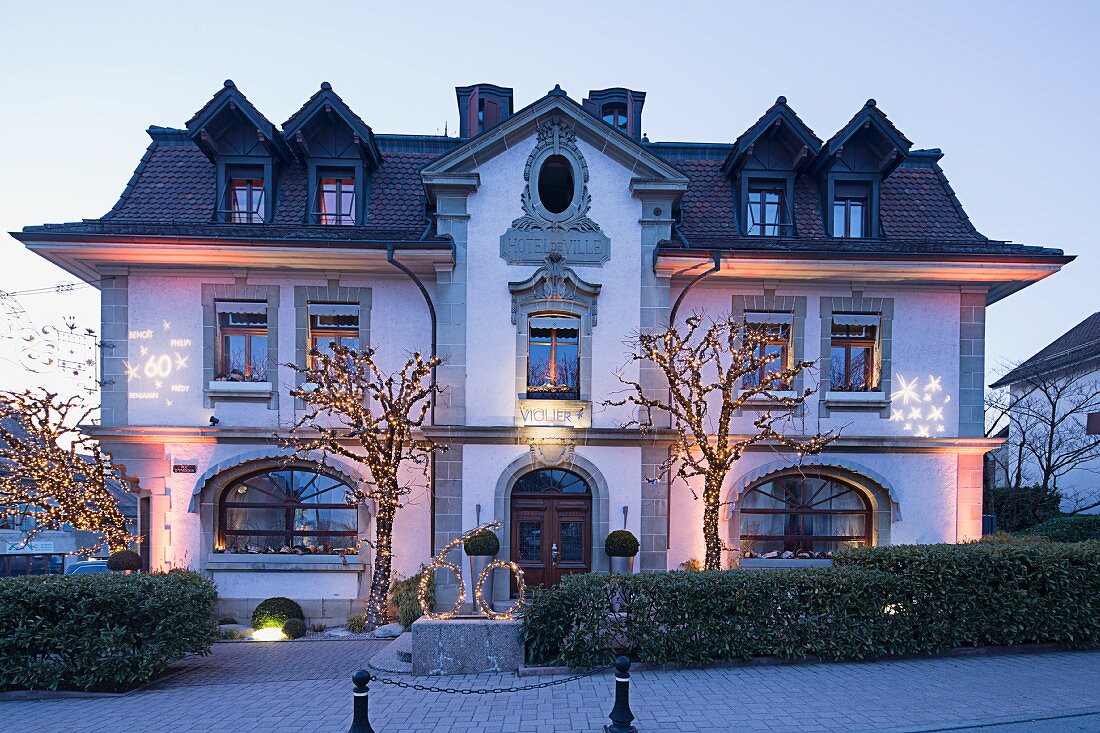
(0, 641), (1100, 733)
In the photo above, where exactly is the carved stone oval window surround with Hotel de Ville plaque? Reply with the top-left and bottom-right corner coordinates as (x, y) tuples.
(501, 119), (611, 264)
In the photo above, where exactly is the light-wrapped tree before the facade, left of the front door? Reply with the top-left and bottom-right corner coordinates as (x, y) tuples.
(284, 342), (441, 628)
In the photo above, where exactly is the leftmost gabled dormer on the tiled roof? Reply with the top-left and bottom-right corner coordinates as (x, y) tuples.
(186, 79), (290, 223)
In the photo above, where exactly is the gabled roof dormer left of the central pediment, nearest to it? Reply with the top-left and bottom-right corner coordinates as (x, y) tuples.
(283, 81), (382, 226)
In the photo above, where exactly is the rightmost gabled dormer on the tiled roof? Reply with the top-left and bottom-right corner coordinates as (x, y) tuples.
(812, 99), (913, 239)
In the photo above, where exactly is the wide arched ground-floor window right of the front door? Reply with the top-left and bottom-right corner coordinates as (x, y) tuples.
(740, 473), (871, 555)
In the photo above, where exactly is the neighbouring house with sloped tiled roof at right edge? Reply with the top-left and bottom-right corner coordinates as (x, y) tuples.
(988, 313), (1100, 512)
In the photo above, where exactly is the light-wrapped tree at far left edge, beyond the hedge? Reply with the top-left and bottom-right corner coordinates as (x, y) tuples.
(0, 389), (133, 555)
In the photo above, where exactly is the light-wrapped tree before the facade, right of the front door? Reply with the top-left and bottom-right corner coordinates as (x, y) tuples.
(606, 314), (836, 570)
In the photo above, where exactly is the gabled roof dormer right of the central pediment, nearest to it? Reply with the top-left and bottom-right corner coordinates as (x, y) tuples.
(722, 97), (822, 237)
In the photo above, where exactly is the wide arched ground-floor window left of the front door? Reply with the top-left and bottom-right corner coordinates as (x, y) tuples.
(217, 468), (359, 555)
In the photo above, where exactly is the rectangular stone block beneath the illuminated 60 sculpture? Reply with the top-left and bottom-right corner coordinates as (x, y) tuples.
(413, 619), (524, 675)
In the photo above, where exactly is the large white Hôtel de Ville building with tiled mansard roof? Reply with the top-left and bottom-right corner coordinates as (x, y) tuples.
(14, 81), (1071, 617)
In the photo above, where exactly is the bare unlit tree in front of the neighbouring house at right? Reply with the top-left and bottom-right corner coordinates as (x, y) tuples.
(986, 370), (1100, 514)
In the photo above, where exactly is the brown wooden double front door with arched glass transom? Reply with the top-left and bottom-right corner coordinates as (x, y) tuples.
(509, 469), (592, 591)
